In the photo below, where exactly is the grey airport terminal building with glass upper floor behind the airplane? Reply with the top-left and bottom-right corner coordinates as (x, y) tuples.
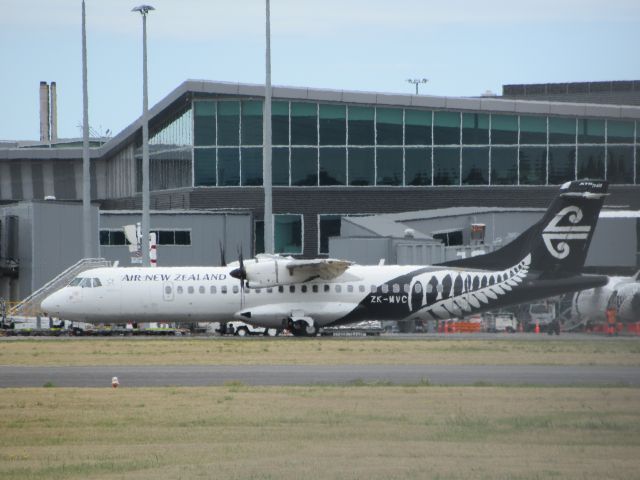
(0, 81), (640, 298)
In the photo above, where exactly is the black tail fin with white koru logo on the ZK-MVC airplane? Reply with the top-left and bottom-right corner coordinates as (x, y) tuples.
(442, 180), (608, 276)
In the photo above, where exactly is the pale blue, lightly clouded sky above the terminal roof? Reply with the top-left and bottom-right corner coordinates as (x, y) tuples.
(0, 0), (640, 140)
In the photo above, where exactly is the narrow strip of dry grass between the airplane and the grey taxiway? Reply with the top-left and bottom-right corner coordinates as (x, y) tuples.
(0, 335), (640, 366)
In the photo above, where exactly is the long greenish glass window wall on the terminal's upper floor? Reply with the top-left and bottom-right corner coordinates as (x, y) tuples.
(190, 99), (640, 188)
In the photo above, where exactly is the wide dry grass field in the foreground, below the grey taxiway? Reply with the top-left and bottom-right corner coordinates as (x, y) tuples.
(0, 384), (640, 480)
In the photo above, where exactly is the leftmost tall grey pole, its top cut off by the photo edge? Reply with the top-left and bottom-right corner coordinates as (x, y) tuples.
(82, 0), (92, 258)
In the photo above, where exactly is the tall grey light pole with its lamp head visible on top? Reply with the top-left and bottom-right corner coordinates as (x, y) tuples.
(131, 5), (155, 267)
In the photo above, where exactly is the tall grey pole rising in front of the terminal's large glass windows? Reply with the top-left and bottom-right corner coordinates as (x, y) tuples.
(262, 0), (274, 253)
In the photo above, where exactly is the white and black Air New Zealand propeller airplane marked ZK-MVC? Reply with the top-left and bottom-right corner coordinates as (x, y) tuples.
(42, 180), (607, 335)
